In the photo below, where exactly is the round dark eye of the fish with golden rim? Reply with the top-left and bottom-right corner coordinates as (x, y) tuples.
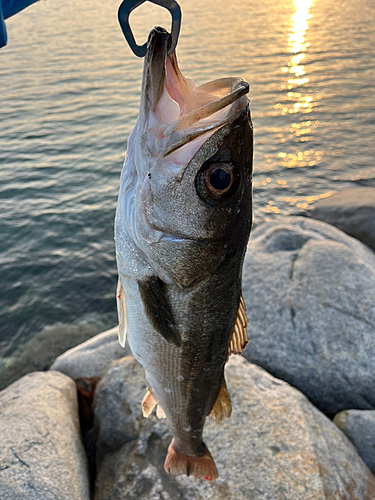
(196, 163), (239, 204)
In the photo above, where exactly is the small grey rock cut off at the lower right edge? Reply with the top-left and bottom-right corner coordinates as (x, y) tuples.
(333, 410), (375, 476)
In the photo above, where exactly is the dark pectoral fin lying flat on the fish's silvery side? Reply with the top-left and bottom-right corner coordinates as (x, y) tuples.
(138, 276), (181, 347)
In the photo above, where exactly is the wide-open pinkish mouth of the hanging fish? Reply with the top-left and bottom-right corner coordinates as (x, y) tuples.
(141, 27), (249, 158)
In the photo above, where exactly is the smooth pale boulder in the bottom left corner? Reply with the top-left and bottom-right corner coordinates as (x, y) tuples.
(0, 371), (90, 500)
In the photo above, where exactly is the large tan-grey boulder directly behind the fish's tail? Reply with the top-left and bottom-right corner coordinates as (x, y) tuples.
(94, 356), (375, 500)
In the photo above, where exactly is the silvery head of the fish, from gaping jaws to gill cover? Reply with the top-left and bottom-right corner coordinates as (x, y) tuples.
(118, 28), (253, 287)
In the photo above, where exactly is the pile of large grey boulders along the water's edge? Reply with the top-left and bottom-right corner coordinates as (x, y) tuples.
(0, 189), (375, 500)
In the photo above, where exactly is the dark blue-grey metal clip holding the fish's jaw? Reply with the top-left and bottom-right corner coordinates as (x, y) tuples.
(118, 0), (181, 57)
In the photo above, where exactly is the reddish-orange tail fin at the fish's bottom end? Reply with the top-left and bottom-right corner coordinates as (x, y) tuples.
(164, 439), (218, 481)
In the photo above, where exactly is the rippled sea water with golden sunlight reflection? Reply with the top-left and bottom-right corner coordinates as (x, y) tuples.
(0, 0), (375, 357)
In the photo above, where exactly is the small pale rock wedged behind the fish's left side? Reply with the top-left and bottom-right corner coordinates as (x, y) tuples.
(51, 326), (130, 379)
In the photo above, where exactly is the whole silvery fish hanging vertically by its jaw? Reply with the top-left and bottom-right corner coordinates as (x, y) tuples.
(115, 27), (253, 481)
